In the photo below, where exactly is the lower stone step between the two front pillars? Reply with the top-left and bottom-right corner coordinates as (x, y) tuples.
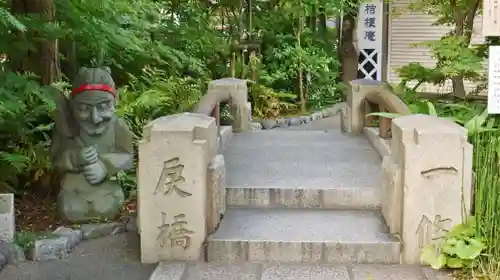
(207, 208), (400, 264)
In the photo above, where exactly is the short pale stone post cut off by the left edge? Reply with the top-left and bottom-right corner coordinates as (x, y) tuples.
(0, 193), (16, 243)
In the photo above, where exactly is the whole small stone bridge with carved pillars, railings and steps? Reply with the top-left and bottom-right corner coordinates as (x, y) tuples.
(138, 79), (472, 279)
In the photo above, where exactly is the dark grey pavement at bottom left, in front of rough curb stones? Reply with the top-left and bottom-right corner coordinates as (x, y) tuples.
(0, 233), (156, 280)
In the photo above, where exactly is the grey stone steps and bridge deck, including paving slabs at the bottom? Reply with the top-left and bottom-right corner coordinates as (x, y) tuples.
(146, 117), (458, 280)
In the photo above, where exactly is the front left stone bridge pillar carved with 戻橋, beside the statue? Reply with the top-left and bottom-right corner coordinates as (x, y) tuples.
(137, 113), (217, 263)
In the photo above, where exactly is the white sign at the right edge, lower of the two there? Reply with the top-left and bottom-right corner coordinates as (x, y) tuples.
(488, 46), (500, 114)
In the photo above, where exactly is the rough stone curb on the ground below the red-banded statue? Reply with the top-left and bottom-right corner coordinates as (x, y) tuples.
(0, 216), (137, 272)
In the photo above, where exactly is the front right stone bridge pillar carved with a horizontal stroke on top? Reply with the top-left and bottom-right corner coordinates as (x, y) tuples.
(382, 115), (472, 264)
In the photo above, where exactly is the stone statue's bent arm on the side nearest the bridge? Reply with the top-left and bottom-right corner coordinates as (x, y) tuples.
(100, 119), (134, 175)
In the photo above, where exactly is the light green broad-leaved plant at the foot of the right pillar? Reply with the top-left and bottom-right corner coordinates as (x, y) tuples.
(420, 217), (486, 269)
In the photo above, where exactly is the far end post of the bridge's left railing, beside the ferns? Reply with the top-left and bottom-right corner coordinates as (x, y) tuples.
(207, 78), (252, 132)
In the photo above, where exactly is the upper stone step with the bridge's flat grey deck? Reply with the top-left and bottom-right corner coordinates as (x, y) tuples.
(224, 131), (381, 209)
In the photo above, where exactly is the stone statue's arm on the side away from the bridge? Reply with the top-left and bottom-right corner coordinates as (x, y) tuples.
(50, 130), (79, 172)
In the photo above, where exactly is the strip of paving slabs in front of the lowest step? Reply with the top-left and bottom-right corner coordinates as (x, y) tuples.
(151, 263), (452, 280)
